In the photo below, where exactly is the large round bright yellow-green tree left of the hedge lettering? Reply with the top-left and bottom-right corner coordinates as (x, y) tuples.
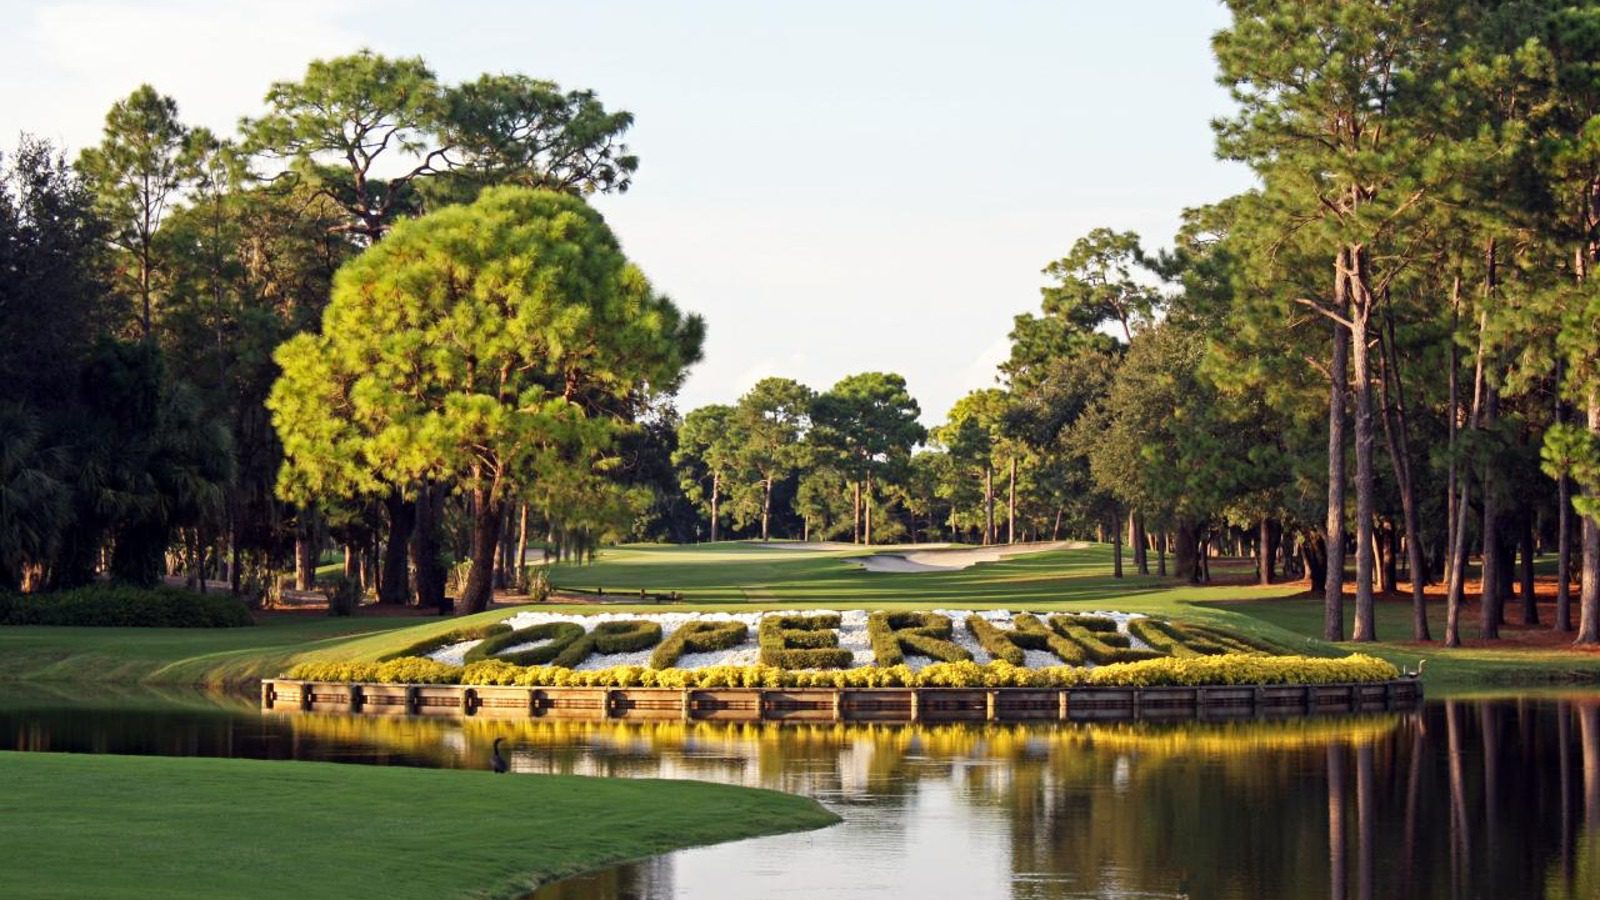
(269, 187), (702, 612)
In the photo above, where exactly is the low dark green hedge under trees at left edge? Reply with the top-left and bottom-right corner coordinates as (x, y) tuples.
(0, 585), (254, 628)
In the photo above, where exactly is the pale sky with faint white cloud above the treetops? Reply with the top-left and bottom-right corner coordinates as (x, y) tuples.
(0, 0), (1250, 423)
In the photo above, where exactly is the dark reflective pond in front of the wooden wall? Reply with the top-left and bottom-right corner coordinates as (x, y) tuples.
(0, 685), (1600, 900)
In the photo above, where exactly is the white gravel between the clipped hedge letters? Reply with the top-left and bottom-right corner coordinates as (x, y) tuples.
(429, 609), (1144, 671)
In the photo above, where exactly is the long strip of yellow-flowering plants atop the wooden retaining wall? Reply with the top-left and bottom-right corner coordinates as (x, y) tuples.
(285, 653), (1400, 689)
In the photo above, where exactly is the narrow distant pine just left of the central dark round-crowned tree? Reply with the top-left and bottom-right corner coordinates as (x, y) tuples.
(733, 378), (816, 541)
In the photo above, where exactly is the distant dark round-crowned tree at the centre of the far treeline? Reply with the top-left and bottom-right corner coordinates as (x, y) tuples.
(811, 372), (928, 544)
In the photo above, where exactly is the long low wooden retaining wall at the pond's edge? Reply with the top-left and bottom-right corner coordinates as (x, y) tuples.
(261, 679), (1422, 722)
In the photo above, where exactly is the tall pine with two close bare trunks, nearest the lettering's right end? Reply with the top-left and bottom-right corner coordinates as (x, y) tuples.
(1213, 0), (1453, 641)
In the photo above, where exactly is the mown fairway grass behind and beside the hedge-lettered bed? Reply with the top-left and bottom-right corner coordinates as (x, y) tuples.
(0, 543), (1600, 692)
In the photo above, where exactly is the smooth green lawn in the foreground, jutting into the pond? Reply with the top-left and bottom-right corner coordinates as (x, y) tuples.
(0, 753), (838, 898)
